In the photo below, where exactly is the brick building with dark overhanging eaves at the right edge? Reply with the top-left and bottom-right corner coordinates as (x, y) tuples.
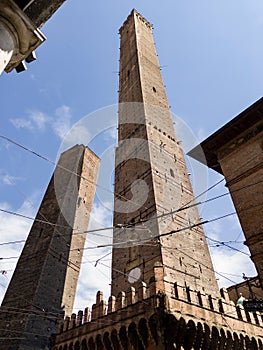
(189, 98), (263, 298)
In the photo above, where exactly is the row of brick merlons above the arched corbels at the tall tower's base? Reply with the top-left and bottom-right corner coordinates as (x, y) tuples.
(59, 278), (263, 334)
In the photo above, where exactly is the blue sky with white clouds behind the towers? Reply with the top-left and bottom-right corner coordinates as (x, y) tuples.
(0, 0), (263, 311)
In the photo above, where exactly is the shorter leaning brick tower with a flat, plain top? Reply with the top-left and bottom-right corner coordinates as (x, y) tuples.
(0, 145), (99, 350)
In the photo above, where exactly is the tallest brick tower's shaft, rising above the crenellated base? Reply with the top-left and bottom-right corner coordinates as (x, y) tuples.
(112, 10), (219, 295)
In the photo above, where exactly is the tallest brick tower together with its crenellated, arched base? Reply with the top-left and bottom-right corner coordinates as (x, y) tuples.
(51, 10), (263, 350)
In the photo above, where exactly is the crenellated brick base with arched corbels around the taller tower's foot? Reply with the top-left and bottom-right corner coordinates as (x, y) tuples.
(52, 269), (263, 350)
